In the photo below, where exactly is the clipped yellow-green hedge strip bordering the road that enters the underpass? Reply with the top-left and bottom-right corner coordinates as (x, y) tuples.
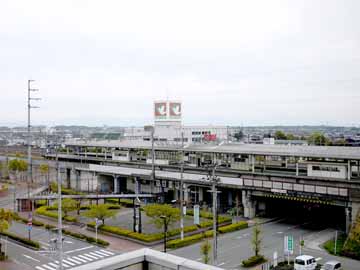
(166, 221), (248, 249)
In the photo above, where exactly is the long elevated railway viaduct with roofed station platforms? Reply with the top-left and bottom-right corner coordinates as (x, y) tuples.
(46, 142), (360, 233)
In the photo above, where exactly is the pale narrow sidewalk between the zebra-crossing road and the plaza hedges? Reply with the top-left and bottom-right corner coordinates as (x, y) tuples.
(19, 213), (145, 252)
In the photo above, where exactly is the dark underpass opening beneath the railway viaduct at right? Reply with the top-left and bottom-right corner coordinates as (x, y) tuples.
(254, 195), (346, 231)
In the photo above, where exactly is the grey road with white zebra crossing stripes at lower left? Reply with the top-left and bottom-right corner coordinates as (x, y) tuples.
(7, 223), (119, 270)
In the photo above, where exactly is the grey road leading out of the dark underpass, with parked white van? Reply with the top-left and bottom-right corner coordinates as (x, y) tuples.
(170, 221), (360, 270)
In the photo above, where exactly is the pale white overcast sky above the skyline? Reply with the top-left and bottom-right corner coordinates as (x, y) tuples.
(0, 0), (360, 126)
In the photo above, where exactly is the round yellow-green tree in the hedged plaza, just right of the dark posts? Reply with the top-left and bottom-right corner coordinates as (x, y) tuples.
(144, 204), (180, 228)
